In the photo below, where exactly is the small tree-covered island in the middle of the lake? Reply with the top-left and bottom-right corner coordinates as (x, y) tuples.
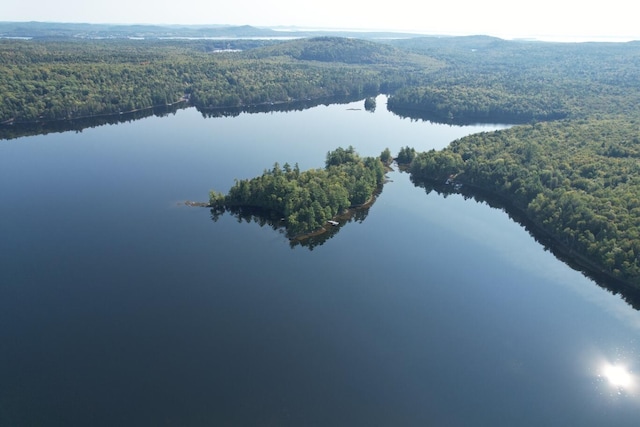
(209, 146), (385, 238)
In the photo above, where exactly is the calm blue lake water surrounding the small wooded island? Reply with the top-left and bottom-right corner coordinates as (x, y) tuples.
(0, 98), (640, 427)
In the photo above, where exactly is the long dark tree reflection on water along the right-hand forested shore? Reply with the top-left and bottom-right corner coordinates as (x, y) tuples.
(411, 176), (640, 310)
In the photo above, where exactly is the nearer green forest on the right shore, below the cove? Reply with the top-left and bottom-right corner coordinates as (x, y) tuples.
(409, 117), (640, 289)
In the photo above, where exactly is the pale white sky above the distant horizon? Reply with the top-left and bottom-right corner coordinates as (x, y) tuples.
(5, 0), (640, 41)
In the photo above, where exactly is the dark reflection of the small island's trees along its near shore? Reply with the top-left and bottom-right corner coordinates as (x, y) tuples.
(211, 202), (373, 251)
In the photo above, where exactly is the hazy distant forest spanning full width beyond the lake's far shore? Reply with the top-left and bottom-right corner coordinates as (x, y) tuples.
(5, 37), (640, 123)
